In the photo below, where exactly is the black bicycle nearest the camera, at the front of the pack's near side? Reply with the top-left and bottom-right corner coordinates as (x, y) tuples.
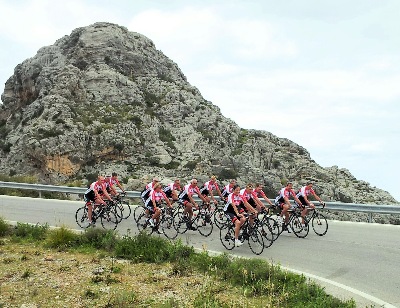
(219, 214), (265, 255)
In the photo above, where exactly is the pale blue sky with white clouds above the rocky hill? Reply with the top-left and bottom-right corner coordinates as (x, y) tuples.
(0, 0), (400, 201)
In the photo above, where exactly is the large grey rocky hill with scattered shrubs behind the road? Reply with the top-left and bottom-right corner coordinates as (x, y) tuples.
(0, 23), (396, 204)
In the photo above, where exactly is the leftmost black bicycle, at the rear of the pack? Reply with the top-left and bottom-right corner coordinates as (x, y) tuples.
(75, 202), (119, 230)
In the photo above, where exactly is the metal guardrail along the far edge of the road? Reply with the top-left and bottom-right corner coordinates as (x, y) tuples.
(0, 181), (400, 222)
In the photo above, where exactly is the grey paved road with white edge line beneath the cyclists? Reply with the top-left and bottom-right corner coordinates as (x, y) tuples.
(0, 196), (400, 307)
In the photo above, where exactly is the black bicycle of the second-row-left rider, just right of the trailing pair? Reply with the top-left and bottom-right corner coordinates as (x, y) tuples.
(136, 206), (178, 240)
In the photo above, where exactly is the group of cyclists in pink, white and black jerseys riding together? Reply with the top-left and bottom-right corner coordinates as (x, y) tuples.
(84, 173), (324, 247)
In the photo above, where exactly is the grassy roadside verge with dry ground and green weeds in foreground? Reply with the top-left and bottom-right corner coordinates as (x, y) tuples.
(0, 218), (355, 308)
